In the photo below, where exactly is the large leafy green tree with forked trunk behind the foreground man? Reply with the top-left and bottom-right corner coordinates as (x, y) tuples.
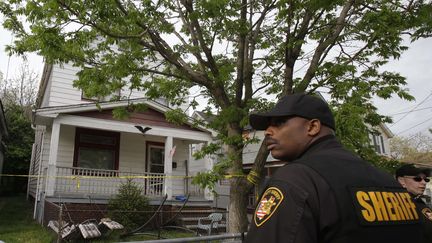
(0, 0), (432, 232)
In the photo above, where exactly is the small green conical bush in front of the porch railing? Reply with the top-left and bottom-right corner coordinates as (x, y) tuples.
(108, 179), (151, 230)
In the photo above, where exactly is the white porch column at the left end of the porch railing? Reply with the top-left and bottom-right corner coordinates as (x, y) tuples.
(46, 120), (60, 196)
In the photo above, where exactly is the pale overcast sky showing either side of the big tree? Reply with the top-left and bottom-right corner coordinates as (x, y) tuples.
(0, 23), (432, 137)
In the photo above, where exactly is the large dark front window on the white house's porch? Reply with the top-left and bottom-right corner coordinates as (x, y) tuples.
(73, 128), (120, 170)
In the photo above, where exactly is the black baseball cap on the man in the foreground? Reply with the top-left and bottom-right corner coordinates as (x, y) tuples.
(249, 93), (335, 130)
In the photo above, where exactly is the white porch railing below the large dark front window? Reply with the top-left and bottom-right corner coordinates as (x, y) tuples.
(55, 166), (165, 197)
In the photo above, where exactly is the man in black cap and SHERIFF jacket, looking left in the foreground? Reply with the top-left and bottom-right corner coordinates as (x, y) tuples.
(246, 94), (421, 243)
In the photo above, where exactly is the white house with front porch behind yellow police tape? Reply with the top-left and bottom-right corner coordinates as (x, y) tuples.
(28, 64), (212, 222)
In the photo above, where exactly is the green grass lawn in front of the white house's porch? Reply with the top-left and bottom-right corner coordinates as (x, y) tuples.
(0, 195), (194, 243)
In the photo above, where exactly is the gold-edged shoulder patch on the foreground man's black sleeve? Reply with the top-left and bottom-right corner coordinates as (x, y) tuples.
(254, 187), (284, 227)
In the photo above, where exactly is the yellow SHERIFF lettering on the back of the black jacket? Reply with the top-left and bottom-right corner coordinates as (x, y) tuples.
(351, 188), (419, 226)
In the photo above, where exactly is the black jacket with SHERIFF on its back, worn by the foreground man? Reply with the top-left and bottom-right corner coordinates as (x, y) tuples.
(246, 136), (420, 243)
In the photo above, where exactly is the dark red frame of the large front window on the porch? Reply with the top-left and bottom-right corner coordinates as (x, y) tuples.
(73, 127), (120, 171)
